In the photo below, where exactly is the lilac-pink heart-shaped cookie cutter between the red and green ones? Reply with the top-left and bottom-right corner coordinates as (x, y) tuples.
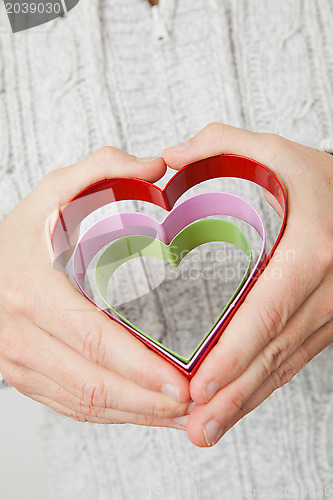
(72, 191), (266, 369)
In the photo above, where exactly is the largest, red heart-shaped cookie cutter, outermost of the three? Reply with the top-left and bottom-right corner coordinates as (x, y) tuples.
(51, 155), (287, 378)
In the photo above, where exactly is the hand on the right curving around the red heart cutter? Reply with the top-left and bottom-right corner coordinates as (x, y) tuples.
(162, 123), (333, 446)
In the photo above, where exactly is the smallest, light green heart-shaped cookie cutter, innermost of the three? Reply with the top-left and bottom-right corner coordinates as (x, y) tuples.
(95, 219), (252, 363)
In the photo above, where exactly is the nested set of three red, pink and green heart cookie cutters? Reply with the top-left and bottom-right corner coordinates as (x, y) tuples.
(52, 155), (287, 378)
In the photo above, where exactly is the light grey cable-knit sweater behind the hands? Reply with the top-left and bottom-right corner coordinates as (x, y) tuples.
(0, 0), (333, 500)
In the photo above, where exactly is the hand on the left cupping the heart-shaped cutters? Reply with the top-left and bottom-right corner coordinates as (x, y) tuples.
(0, 147), (190, 429)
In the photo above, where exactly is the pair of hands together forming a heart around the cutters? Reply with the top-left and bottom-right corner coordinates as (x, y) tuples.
(0, 123), (333, 446)
